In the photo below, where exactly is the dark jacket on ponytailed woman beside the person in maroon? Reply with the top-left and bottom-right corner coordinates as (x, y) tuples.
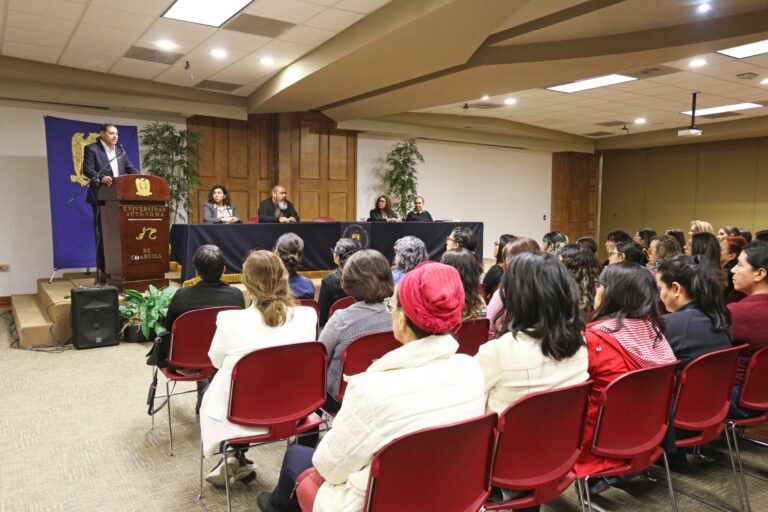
(664, 302), (732, 366)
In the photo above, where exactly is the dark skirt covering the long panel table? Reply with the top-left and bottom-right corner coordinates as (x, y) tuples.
(171, 222), (483, 280)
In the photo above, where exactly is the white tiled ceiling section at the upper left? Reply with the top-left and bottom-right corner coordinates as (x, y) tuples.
(0, 0), (389, 96)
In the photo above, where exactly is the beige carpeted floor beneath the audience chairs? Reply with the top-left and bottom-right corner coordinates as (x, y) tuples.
(0, 314), (768, 512)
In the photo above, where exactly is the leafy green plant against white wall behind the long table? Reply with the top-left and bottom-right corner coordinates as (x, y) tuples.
(384, 139), (424, 219)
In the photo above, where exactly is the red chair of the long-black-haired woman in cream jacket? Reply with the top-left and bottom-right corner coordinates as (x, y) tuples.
(485, 381), (592, 510)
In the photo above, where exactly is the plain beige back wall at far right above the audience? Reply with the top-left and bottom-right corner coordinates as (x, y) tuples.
(600, 137), (768, 253)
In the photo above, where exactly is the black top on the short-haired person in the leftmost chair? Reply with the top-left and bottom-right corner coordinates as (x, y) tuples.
(147, 281), (245, 367)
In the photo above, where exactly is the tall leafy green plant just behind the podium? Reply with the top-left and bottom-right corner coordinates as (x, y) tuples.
(139, 121), (200, 223)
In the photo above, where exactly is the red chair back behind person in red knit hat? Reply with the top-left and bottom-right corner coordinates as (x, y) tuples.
(365, 413), (496, 512)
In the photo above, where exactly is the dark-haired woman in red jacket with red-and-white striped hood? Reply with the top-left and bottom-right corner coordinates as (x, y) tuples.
(576, 262), (676, 486)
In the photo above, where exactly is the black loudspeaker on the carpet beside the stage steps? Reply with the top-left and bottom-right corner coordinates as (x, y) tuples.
(71, 286), (120, 349)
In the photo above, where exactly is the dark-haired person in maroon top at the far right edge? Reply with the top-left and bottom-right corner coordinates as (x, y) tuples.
(728, 241), (768, 418)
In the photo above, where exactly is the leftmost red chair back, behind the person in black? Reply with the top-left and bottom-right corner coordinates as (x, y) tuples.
(168, 306), (240, 375)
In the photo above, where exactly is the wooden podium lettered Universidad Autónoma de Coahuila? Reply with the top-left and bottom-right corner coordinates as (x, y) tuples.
(99, 174), (169, 292)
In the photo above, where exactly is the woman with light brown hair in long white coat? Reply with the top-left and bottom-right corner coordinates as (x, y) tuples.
(200, 251), (317, 486)
